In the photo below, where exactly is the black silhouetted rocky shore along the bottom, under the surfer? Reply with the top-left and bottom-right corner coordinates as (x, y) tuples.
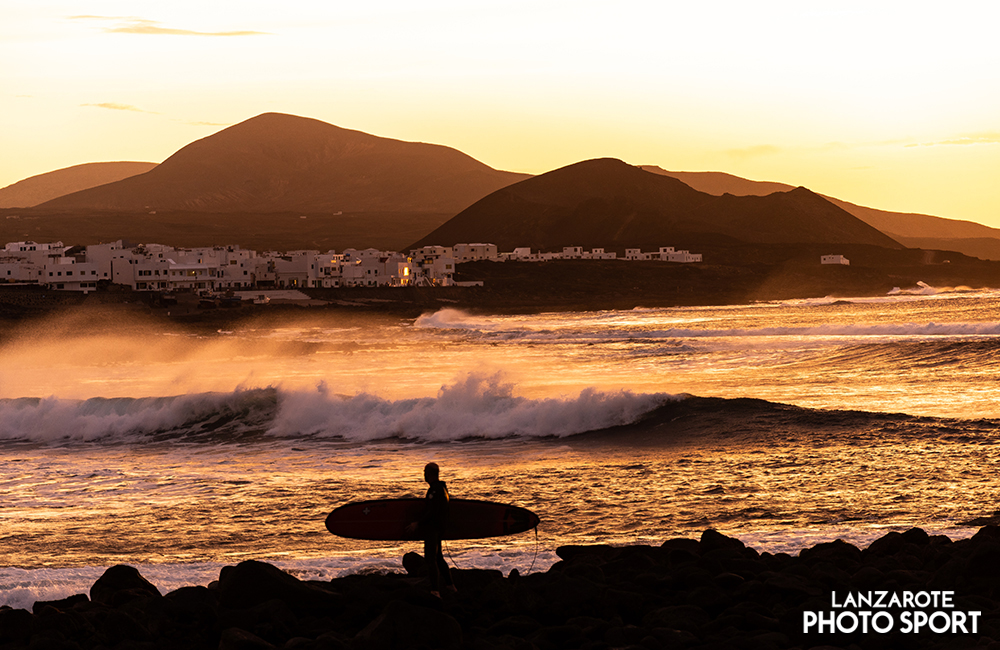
(0, 526), (1000, 650)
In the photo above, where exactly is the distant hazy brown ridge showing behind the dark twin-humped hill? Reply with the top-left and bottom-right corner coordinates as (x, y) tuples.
(642, 165), (1000, 260)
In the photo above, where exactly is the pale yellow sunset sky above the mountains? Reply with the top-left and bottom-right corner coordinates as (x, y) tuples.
(0, 0), (1000, 227)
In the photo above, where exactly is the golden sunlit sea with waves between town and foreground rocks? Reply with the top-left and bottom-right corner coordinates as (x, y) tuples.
(0, 287), (1000, 607)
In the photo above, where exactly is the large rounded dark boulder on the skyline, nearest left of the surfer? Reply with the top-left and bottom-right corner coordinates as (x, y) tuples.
(219, 560), (342, 608)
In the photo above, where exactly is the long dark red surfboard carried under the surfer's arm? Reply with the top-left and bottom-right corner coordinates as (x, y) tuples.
(326, 499), (539, 540)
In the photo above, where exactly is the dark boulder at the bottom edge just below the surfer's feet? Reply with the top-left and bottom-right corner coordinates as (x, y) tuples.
(354, 600), (462, 650)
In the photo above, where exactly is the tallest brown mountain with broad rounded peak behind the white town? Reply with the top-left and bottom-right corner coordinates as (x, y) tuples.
(40, 113), (527, 214)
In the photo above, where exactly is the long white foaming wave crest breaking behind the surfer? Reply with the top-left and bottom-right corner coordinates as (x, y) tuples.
(0, 373), (678, 443)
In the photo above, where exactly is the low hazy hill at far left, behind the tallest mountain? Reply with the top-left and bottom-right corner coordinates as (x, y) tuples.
(0, 162), (156, 208)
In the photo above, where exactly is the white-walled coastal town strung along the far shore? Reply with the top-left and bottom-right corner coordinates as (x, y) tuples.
(0, 240), (702, 293)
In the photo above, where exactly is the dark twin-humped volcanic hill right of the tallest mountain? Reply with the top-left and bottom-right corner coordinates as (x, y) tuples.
(414, 158), (902, 252)
